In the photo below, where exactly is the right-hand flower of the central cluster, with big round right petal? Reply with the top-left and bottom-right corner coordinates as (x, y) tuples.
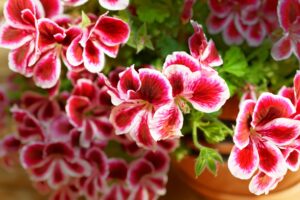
(163, 52), (229, 113)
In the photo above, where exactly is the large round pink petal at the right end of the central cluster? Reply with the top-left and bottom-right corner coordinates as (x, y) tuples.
(185, 74), (230, 113)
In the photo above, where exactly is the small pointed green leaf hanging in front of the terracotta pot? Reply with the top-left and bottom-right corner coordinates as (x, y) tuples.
(195, 147), (223, 177)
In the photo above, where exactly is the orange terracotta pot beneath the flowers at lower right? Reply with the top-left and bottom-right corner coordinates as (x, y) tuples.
(172, 143), (300, 200)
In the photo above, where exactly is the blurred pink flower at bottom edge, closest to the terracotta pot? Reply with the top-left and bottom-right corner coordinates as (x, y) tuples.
(128, 151), (170, 199)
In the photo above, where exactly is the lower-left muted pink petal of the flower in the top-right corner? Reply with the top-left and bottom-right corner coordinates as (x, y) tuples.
(271, 36), (293, 61)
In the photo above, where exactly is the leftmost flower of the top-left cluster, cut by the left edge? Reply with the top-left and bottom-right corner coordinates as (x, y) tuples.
(0, 0), (62, 86)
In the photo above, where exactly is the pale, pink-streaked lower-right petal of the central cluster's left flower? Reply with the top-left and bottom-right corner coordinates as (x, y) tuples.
(149, 103), (183, 141)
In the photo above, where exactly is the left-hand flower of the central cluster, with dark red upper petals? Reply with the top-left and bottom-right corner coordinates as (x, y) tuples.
(110, 66), (183, 148)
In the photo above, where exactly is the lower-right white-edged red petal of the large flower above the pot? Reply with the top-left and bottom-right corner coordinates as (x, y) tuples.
(256, 141), (287, 178)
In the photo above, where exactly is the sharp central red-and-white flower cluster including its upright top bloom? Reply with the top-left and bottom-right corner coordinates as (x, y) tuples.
(109, 22), (229, 148)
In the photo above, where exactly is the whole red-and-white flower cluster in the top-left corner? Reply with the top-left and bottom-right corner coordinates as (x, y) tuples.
(0, 0), (130, 88)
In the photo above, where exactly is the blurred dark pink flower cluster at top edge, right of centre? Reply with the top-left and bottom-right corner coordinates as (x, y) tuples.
(207, 0), (278, 46)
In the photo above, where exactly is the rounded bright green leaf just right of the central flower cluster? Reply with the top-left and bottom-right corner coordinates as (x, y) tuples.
(220, 46), (248, 77)
